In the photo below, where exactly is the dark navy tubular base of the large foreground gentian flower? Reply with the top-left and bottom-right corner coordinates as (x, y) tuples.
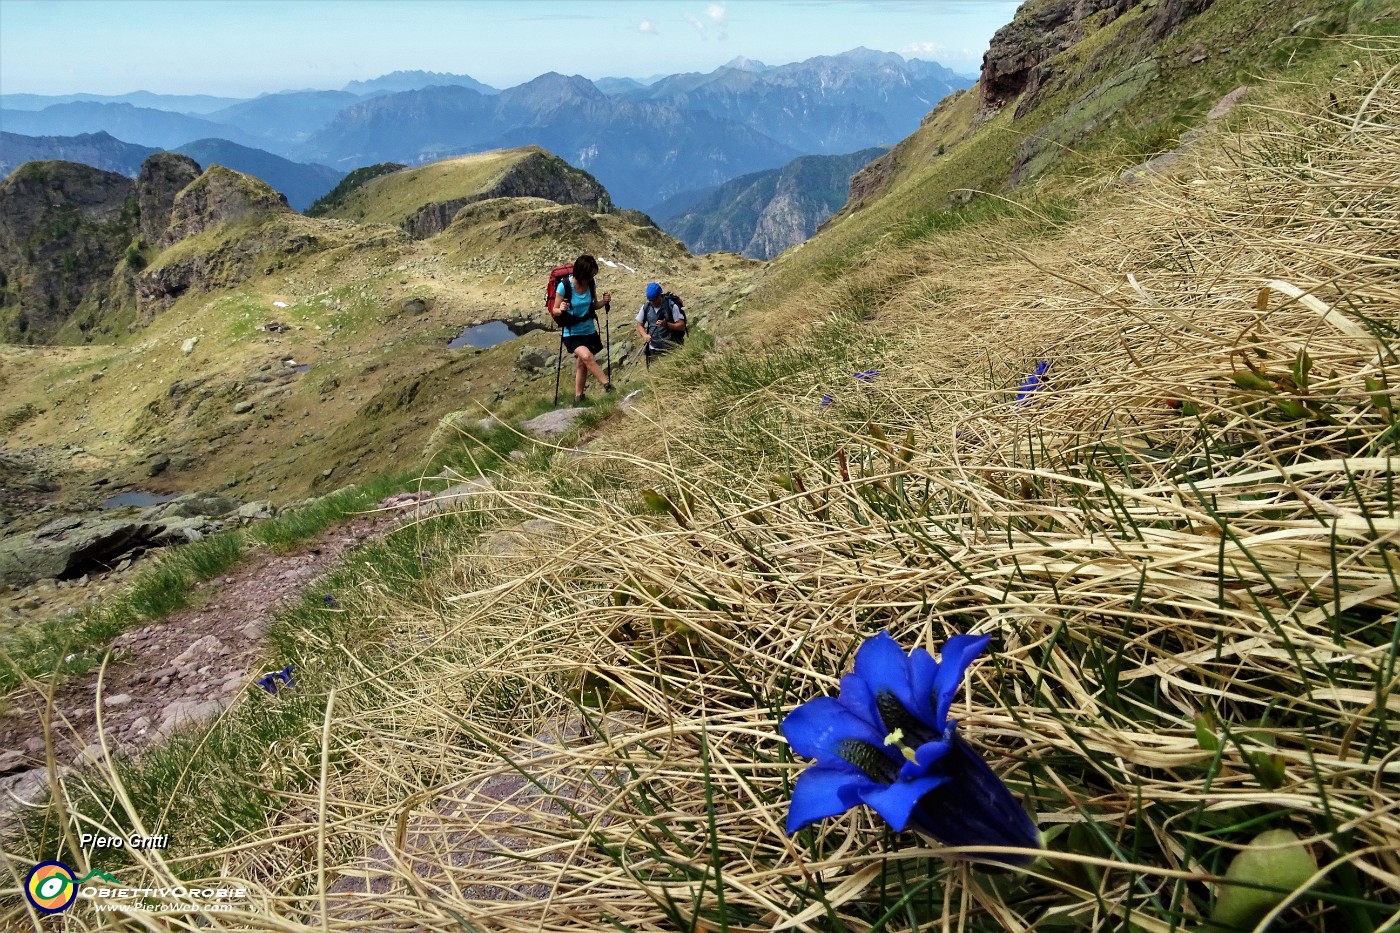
(910, 730), (1040, 866)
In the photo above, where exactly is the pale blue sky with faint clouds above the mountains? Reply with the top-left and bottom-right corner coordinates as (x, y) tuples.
(0, 0), (1018, 97)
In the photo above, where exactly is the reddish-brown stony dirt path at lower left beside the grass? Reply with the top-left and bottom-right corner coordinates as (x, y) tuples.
(0, 490), (434, 818)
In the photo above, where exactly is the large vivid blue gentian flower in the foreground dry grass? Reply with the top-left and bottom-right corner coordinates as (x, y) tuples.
(783, 632), (1040, 866)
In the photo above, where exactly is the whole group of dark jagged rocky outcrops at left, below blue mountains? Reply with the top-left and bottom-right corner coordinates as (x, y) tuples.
(0, 153), (315, 337)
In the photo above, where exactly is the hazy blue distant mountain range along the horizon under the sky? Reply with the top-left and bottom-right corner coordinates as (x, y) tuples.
(0, 49), (972, 210)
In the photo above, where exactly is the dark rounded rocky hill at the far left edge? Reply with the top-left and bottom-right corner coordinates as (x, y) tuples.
(0, 161), (139, 343)
